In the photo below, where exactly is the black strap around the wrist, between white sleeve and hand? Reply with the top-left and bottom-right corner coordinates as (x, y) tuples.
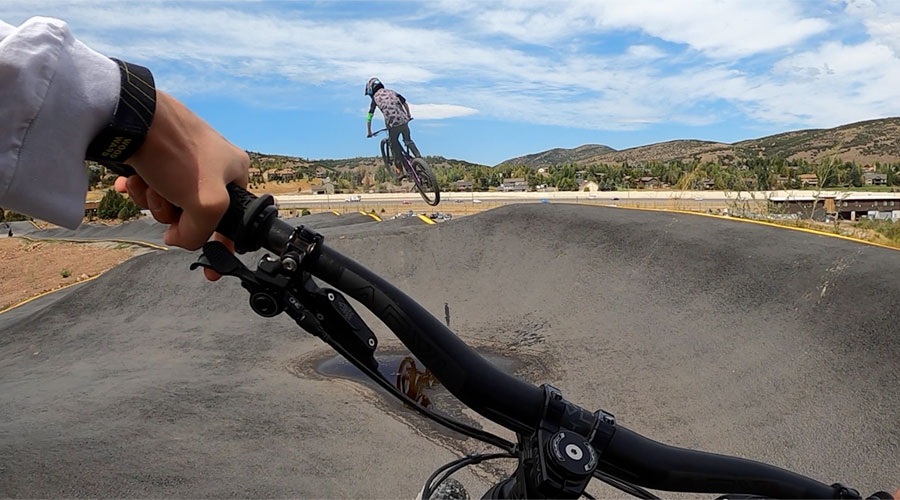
(85, 59), (156, 176)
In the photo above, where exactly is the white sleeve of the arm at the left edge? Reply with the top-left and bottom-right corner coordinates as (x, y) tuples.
(0, 17), (120, 229)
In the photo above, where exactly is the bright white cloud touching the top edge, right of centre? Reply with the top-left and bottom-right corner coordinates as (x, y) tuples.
(448, 0), (829, 58)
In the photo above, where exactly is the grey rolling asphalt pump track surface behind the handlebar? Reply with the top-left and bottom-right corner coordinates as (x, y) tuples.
(0, 205), (900, 498)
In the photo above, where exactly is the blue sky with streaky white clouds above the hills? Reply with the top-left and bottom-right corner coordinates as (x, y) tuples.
(0, 0), (900, 165)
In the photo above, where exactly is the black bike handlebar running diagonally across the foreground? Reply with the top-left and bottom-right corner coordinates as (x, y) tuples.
(211, 184), (856, 498)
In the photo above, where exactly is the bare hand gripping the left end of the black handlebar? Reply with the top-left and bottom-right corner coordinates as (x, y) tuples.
(116, 91), (250, 280)
